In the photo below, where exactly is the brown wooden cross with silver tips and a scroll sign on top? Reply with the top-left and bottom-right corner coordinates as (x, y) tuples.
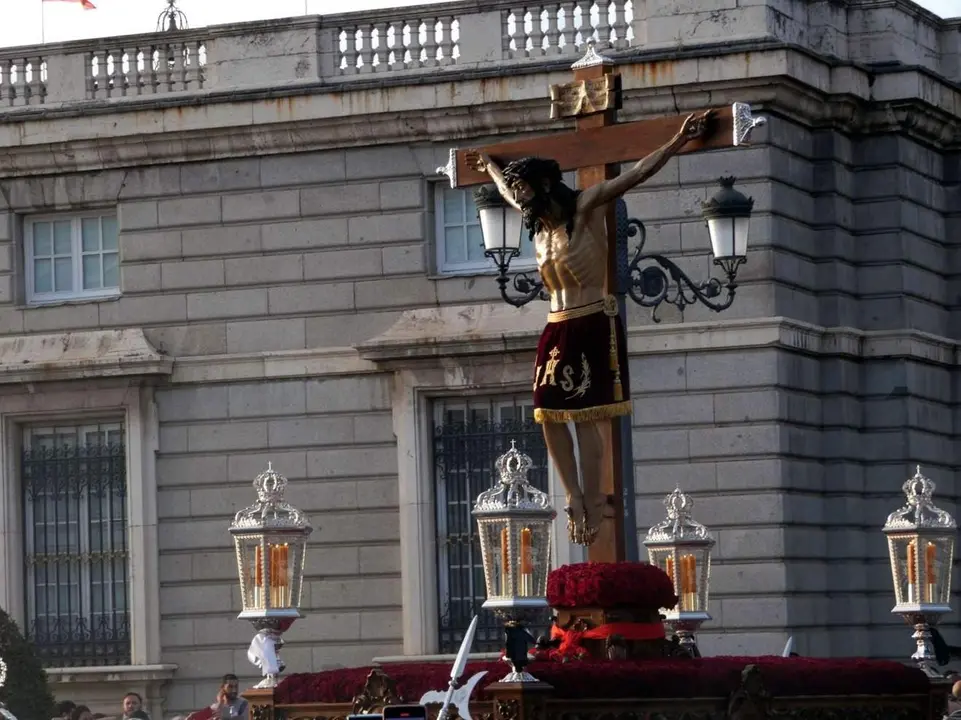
(437, 45), (764, 562)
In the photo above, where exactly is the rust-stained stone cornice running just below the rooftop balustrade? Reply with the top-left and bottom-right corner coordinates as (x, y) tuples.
(0, 43), (961, 176)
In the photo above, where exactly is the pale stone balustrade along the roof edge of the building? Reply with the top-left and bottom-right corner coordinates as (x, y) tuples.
(0, 0), (961, 112)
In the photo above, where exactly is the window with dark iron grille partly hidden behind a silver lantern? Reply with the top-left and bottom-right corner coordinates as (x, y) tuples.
(433, 394), (548, 653)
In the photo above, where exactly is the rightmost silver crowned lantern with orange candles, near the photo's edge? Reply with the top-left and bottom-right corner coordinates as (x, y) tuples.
(882, 466), (958, 677)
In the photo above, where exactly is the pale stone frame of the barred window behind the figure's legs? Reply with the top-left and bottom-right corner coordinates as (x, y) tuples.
(388, 366), (585, 660)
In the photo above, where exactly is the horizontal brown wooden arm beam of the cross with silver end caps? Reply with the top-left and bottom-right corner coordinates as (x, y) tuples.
(437, 103), (764, 188)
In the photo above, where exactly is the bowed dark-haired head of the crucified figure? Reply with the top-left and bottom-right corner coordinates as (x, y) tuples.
(503, 157), (577, 238)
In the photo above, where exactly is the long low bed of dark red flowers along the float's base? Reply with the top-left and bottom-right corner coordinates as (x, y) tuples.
(274, 657), (930, 704)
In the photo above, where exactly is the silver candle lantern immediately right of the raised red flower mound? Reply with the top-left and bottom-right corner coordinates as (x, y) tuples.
(644, 488), (714, 657)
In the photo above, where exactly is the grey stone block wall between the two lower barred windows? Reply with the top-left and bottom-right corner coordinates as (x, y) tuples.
(157, 374), (403, 712)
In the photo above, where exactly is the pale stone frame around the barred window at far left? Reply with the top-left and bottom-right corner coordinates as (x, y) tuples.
(0, 386), (174, 683)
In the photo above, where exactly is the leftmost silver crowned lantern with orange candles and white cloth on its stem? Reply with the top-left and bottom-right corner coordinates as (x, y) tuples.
(230, 463), (313, 688)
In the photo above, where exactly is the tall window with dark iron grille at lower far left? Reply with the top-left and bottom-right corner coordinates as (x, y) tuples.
(21, 422), (130, 667)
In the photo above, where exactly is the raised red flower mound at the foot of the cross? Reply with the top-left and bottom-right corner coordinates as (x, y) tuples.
(547, 562), (677, 610)
